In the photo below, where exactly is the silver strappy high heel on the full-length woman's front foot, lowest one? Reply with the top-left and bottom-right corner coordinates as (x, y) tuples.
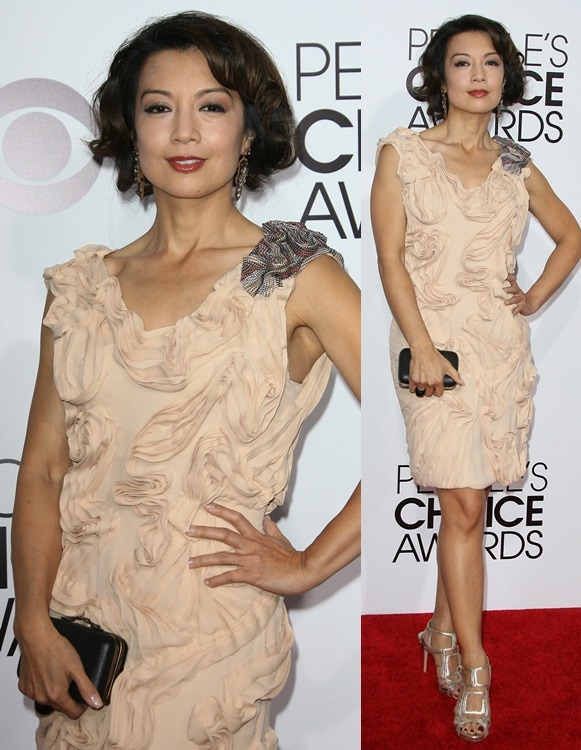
(454, 659), (492, 742)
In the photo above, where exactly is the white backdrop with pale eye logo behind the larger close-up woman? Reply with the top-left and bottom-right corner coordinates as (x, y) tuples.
(0, 0), (362, 750)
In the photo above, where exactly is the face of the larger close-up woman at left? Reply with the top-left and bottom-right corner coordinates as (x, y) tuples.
(135, 50), (251, 203)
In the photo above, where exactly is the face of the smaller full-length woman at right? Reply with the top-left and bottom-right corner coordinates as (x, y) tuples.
(443, 31), (504, 114)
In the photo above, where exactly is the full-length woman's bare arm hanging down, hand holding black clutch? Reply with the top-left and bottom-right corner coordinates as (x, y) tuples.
(371, 145), (463, 396)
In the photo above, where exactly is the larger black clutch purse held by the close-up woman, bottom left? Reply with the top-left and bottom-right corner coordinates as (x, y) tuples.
(18, 616), (127, 715)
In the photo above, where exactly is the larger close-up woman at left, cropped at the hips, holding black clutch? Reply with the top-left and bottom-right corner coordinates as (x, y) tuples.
(13, 12), (360, 750)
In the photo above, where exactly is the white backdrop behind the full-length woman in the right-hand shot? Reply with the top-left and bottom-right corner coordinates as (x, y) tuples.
(362, 0), (581, 613)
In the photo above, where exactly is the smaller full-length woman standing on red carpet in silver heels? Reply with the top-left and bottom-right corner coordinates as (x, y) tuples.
(371, 15), (581, 742)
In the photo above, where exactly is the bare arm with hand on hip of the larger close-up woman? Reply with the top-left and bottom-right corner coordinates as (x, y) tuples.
(190, 257), (361, 595)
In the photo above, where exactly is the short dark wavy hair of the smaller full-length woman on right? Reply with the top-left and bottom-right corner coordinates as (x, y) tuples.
(414, 15), (525, 121)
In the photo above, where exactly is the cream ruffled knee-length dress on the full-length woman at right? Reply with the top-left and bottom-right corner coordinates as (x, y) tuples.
(379, 128), (536, 489)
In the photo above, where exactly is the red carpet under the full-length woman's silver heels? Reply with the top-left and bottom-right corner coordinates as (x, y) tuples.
(361, 609), (581, 750)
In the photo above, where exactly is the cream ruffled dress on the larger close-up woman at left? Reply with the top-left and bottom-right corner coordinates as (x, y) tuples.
(37, 222), (341, 750)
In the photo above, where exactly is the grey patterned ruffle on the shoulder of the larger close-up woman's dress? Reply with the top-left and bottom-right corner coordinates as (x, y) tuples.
(240, 221), (343, 297)
